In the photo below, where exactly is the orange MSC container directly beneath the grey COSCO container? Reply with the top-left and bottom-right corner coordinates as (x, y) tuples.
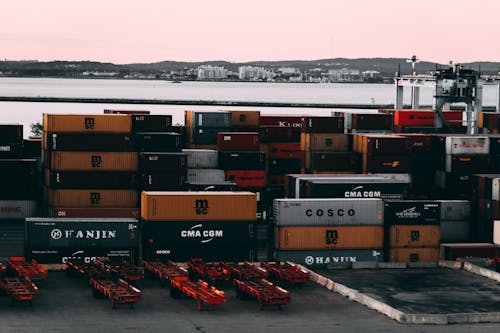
(275, 226), (384, 250)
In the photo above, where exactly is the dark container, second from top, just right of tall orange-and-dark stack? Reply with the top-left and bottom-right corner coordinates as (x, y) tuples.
(136, 132), (182, 152)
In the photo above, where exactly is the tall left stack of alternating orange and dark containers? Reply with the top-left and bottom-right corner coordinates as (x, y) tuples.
(42, 114), (139, 218)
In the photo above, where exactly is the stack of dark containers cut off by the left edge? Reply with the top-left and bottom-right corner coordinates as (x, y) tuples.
(0, 124), (40, 257)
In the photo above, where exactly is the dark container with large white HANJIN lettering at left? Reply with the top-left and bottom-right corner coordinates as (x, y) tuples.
(25, 218), (141, 249)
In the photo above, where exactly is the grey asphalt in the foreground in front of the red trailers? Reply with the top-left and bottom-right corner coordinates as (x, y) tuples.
(0, 270), (500, 333)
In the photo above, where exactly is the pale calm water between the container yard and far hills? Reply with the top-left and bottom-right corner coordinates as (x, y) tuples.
(0, 78), (496, 136)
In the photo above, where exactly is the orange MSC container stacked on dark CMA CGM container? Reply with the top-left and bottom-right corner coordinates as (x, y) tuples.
(141, 191), (256, 261)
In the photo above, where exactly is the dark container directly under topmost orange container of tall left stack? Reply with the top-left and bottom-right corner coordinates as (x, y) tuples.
(42, 131), (135, 152)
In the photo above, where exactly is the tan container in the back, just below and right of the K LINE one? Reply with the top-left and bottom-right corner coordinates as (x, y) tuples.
(300, 133), (350, 152)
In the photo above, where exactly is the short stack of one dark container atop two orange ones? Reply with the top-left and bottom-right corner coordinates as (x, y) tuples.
(384, 200), (441, 263)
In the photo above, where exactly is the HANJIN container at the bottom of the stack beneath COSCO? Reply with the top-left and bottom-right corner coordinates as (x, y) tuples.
(273, 249), (384, 269)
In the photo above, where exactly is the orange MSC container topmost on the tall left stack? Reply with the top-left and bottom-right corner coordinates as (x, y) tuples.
(43, 113), (132, 133)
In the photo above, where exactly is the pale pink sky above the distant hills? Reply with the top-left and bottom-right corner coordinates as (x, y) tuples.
(0, 0), (500, 64)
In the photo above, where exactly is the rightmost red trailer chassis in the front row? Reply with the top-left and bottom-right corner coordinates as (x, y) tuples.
(233, 279), (292, 310)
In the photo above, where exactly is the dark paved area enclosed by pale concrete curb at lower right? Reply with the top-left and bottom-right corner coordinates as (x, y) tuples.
(327, 268), (500, 314)
